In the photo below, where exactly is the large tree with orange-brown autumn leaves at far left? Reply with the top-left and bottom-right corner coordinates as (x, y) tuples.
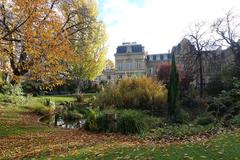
(0, 0), (77, 88)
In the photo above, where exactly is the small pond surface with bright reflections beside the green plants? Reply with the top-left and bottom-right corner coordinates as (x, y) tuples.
(40, 115), (86, 129)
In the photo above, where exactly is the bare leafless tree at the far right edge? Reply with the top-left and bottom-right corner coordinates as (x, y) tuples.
(212, 11), (240, 78)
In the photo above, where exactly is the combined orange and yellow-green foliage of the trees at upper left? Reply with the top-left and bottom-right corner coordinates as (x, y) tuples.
(0, 0), (106, 89)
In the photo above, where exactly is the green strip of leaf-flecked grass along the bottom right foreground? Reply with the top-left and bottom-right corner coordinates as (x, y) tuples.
(60, 130), (240, 160)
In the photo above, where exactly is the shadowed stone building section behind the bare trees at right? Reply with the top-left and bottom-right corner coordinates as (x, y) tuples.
(172, 39), (234, 85)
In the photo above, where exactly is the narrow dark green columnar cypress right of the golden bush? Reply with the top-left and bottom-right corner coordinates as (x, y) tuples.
(168, 53), (179, 120)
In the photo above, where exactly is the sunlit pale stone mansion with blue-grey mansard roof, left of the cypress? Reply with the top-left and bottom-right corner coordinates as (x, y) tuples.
(97, 42), (171, 82)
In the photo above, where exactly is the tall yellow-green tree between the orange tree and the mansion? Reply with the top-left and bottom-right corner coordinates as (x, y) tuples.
(61, 0), (107, 93)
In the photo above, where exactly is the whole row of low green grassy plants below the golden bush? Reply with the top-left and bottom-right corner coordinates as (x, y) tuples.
(85, 108), (159, 134)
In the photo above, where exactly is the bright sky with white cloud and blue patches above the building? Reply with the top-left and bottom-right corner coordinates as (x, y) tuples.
(98, 0), (240, 60)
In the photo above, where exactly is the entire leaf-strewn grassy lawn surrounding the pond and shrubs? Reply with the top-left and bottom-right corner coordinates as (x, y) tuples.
(0, 95), (240, 160)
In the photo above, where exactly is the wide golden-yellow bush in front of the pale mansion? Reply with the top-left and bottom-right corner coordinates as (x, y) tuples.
(96, 77), (167, 110)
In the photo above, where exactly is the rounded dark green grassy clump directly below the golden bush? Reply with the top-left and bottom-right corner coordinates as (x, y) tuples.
(117, 110), (146, 134)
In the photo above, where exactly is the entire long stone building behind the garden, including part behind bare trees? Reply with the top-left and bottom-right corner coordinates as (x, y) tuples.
(97, 39), (234, 85)
